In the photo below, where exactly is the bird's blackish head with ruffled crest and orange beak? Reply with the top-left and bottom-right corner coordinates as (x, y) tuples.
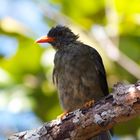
(36, 25), (78, 49)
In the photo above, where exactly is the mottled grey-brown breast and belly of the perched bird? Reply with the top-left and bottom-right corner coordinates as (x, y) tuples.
(54, 48), (102, 111)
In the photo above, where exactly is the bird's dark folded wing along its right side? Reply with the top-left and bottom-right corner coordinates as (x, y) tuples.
(90, 48), (109, 95)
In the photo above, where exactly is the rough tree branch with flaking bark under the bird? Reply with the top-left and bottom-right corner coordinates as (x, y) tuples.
(9, 81), (140, 140)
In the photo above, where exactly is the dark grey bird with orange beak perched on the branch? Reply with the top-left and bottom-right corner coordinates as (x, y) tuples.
(36, 25), (111, 140)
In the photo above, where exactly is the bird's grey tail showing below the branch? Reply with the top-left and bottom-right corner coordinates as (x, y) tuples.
(89, 131), (111, 140)
